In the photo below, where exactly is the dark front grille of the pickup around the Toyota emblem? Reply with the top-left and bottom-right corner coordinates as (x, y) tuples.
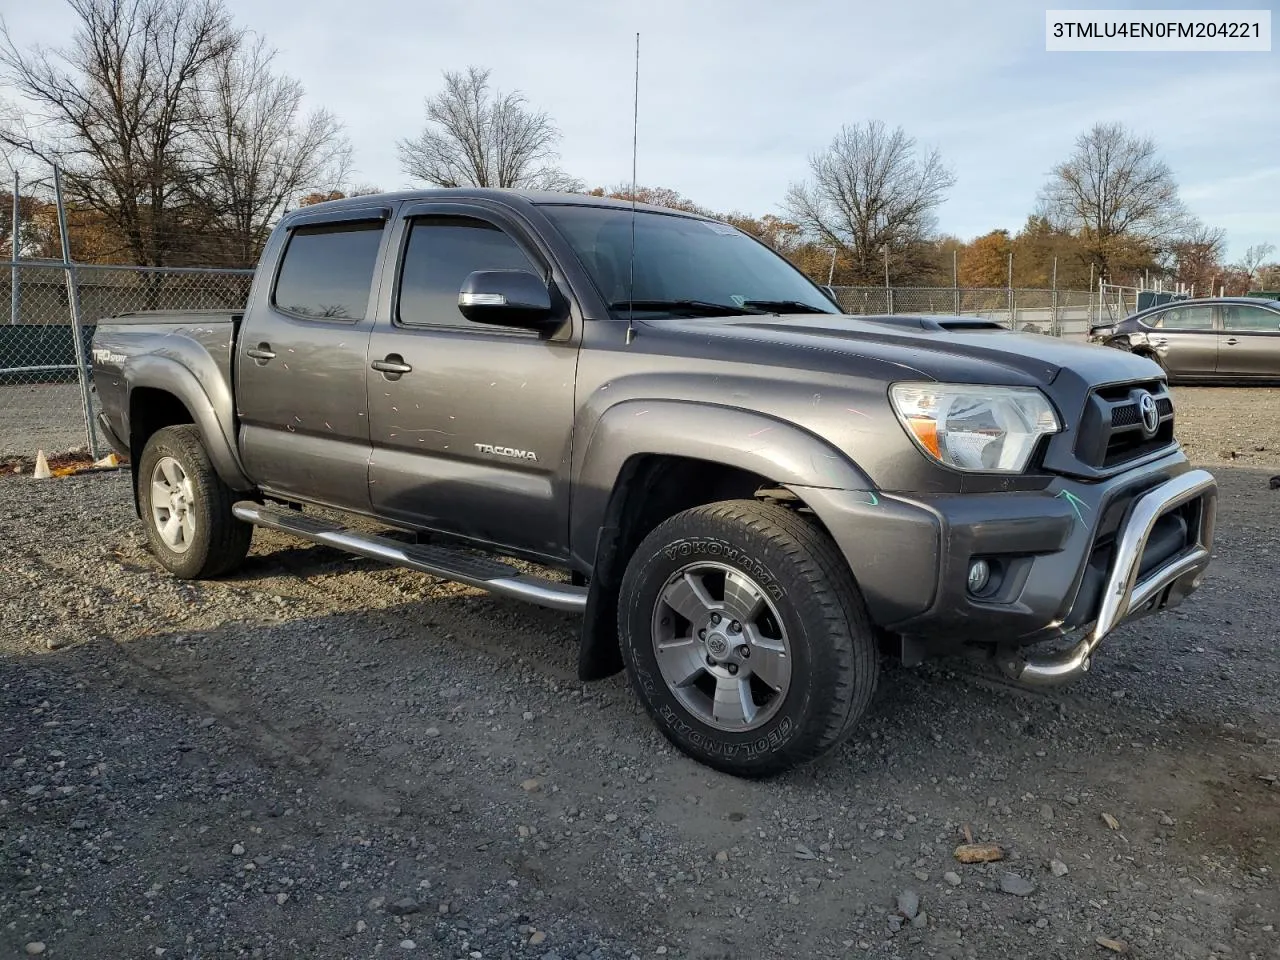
(1075, 380), (1174, 470)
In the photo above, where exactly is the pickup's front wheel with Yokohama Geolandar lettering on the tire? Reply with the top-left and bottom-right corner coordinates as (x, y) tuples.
(618, 500), (879, 777)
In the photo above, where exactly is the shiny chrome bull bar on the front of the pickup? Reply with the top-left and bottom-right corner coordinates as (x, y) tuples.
(1001, 470), (1217, 686)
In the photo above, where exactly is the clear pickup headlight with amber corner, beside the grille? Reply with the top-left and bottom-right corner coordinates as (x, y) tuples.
(890, 383), (1062, 474)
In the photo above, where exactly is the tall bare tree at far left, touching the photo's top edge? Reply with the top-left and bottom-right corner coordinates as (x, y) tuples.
(0, 0), (241, 266)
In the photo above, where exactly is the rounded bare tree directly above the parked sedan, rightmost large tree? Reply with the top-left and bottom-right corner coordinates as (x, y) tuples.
(1041, 123), (1187, 276)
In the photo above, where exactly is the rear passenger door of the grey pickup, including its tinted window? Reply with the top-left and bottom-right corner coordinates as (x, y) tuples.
(236, 207), (388, 511)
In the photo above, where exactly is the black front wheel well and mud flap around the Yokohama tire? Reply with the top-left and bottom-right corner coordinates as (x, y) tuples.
(579, 454), (804, 680)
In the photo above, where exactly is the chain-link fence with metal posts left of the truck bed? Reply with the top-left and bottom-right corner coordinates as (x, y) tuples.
(0, 261), (253, 458)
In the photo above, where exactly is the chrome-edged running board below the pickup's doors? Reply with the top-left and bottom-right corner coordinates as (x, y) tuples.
(232, 500), (586, 613)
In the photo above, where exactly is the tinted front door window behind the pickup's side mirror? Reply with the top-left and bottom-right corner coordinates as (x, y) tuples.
(397, 216), (544, 329)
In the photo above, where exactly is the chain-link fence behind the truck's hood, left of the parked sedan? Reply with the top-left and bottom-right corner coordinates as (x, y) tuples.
(831, 287), (1098, 338)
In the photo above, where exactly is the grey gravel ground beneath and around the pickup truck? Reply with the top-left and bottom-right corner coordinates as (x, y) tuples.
(0, 389), (1280, 960)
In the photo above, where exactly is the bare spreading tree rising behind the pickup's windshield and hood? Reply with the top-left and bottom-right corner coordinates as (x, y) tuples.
(785, 120), (955, 284)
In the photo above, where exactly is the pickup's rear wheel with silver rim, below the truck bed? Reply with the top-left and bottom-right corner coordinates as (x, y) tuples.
(137, 424), (253, 580)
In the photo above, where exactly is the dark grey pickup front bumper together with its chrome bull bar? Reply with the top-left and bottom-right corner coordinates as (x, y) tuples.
(795, 453), (1217, 682)
